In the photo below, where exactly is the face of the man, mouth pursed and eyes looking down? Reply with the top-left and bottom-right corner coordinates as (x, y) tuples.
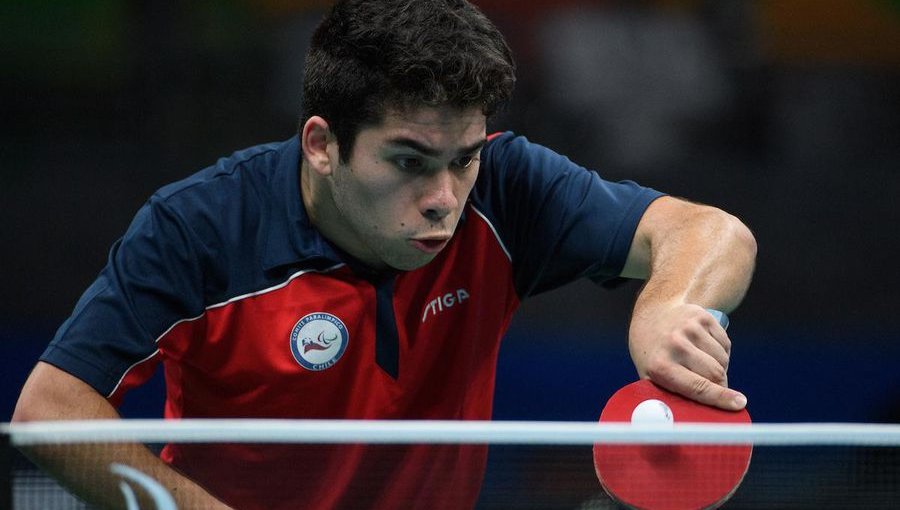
(322, 107), (486, 270)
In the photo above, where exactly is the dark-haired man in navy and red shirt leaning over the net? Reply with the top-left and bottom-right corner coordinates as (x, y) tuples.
(14, 0), (756, 509)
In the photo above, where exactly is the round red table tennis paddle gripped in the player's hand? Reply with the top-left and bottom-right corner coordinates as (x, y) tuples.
(594, 311), (753, 510)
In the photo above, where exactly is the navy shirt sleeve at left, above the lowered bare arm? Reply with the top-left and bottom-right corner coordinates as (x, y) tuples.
(41, 196), (203, 404)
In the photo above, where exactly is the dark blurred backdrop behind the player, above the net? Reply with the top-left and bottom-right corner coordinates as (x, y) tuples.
(0, 0), (900, 421)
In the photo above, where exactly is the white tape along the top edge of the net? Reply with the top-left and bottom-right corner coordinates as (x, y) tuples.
(0, 419), (900, 446)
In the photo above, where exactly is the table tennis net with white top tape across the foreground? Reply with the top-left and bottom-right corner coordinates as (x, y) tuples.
(0, 420), (900, 510)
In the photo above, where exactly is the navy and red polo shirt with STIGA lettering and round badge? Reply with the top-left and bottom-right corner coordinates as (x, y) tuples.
(41, 133), (660, 510)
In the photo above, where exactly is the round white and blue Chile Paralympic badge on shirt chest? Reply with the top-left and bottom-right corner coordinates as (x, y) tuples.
(291, 312), (350, 371)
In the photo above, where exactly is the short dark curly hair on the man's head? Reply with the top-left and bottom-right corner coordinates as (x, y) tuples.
(300, 0), (515, 161)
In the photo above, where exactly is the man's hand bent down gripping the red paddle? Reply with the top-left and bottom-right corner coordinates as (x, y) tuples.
(628, 304), (747, 411)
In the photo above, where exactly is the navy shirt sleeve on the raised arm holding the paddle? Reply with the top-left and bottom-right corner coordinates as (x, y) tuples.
(473, 132), (662, 298)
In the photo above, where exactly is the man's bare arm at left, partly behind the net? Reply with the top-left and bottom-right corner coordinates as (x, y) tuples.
(12, 362), (228, 508)
